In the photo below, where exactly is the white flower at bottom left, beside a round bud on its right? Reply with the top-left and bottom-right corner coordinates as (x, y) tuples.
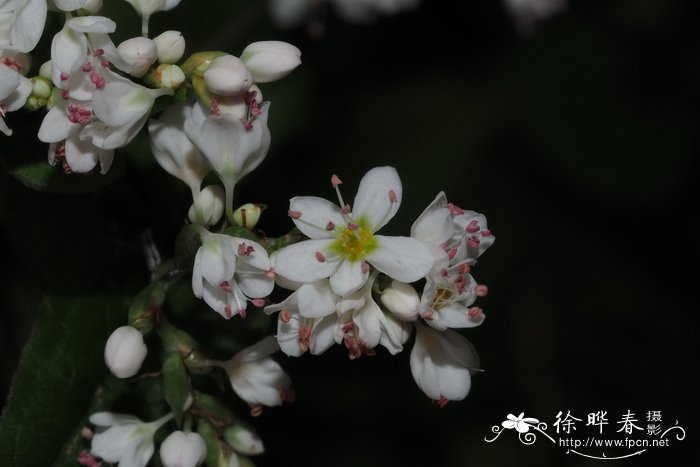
(90, 412), (173, 467)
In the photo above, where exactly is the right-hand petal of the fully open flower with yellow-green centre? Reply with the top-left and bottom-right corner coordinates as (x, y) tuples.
(367, 235), (433, 282)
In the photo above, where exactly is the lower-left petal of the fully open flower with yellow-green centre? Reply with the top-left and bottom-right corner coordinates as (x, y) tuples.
(275, 240), (340, 282)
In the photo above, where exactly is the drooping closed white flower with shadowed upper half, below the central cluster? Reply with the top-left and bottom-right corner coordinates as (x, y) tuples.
(410, 321), (479, 406)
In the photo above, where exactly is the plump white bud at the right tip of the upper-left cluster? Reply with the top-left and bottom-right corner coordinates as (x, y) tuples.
(241, 41), (301, 83)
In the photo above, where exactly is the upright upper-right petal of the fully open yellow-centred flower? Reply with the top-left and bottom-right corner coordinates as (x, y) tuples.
(352, 167), (403, 232)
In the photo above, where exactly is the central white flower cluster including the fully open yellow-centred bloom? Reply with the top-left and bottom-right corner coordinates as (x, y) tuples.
(266, 167), (494, 404)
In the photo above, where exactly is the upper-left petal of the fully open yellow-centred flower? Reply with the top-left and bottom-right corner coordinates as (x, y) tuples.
(289, 196), (347, 239)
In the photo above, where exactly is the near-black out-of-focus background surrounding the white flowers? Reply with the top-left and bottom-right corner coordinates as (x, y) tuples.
(0, 0), (700, 466)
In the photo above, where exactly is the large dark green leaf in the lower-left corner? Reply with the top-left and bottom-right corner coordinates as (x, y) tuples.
(0, 294), (126, 465)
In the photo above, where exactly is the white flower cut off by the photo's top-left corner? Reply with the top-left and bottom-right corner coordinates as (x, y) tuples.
(0, 0), (47, 52)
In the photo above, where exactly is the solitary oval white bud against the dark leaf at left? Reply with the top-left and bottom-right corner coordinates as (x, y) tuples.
(105, 326), (148, 378)
